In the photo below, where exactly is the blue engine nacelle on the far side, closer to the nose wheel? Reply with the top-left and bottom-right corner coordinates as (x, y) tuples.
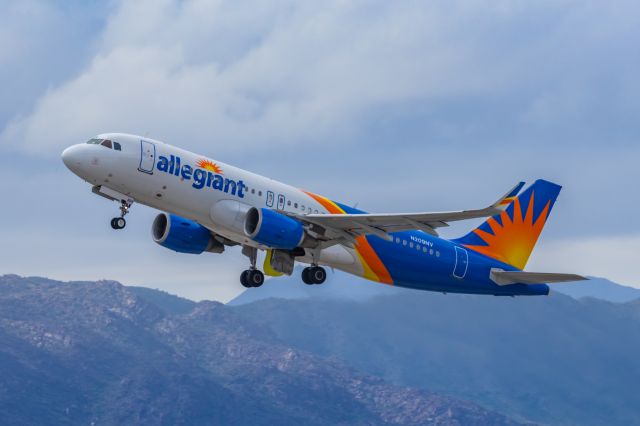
(151, 213), (224, 254)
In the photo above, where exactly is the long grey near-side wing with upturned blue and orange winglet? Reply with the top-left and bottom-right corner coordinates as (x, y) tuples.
(295, 182), (524, 240)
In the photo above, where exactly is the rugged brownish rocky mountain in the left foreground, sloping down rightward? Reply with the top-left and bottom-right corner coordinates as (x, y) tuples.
(0, 275), (516, 425)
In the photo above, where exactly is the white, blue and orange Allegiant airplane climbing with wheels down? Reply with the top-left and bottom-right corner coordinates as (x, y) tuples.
(62, 133), (586, 296)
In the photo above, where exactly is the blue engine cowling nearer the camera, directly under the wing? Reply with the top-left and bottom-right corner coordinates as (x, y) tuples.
(244, 207), (304, 250)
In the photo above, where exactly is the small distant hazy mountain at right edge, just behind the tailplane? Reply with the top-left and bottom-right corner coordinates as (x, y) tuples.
(553, 277), (640, 303)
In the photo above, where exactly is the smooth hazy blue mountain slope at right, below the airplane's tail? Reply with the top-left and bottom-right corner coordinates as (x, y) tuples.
(233, 283), (640, 425)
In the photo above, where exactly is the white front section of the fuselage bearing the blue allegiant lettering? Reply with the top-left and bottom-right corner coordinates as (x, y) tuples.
(62, 133), (364, 276)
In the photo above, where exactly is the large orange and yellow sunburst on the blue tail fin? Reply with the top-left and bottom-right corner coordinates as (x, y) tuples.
(465, 192), (551, 269)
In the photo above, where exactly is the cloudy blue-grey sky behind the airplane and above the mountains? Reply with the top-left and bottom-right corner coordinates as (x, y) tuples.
(0, 0), (640, 301)
